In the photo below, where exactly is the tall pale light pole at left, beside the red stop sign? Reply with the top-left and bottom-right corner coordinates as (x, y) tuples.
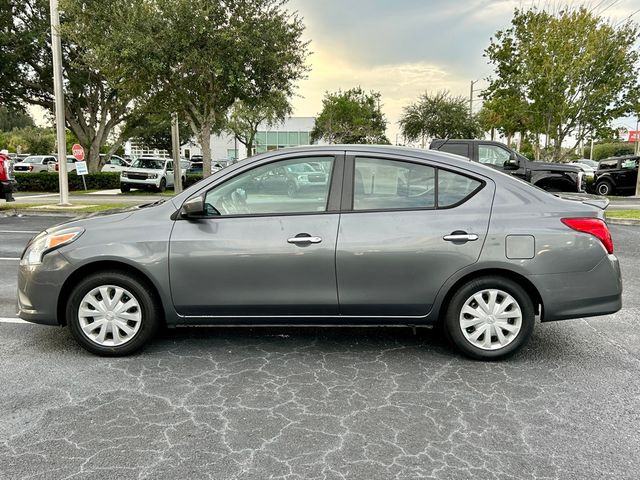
(49, 0), (71, 205)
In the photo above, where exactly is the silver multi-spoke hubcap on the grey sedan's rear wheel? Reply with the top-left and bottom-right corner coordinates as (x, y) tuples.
(460, 289), (522, 350)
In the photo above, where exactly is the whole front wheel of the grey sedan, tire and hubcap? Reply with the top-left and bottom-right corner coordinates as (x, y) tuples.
(66, 271), (161, 356)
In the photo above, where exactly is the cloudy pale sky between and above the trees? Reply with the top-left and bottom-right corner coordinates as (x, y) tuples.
(288, 0), (640, 143)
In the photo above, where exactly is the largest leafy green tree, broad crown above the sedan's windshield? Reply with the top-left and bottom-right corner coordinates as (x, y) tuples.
(61, 0), (307, 175)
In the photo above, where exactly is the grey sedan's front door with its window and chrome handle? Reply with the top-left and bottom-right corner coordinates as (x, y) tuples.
(169, 154), (343, 322)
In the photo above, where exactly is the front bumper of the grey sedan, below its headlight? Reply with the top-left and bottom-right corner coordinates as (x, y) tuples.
(18, 250), (73, 325)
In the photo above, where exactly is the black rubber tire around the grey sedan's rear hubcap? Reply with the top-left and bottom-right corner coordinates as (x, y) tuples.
(444, 276), (535, 360)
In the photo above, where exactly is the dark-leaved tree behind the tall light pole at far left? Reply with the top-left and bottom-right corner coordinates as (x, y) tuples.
(0, 0), (131, 171)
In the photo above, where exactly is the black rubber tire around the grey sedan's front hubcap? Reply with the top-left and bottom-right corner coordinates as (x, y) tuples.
(66, 271), (163, 357)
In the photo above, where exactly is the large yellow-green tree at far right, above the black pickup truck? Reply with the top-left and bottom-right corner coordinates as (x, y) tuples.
(485, 7), (640, 160)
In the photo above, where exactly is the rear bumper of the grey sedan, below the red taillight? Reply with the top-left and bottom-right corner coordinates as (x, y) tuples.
(528, 255), (622, 322)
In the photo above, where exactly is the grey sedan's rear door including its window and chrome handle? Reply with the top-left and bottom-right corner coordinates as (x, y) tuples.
(336, 153), (495, 317)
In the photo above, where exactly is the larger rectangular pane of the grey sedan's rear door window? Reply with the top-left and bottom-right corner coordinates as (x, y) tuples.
(353, 158), (435, 210)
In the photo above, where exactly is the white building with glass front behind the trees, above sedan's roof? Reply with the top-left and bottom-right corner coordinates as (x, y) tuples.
(180, 117), (322, 162)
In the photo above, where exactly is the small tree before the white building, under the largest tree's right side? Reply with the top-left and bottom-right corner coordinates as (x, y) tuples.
(226, 92), (293, 157)
